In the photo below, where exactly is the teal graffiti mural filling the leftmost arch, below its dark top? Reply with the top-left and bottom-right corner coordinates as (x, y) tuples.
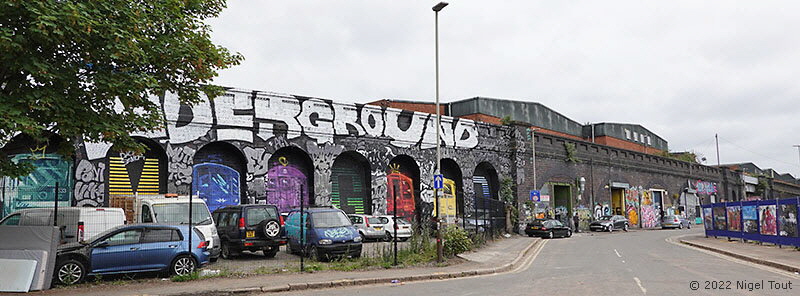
(0, 153), (73, 215)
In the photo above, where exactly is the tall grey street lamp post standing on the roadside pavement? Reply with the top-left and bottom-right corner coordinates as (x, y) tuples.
(433, 2), (447, 262)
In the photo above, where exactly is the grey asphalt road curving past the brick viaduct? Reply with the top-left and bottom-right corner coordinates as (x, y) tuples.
(274, 229), (800, 296)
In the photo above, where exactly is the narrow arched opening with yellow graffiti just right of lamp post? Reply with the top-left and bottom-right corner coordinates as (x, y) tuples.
(434, 158), (464, 223)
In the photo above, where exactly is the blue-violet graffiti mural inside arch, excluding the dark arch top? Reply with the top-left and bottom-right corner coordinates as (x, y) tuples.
(192, 163), (240, 212)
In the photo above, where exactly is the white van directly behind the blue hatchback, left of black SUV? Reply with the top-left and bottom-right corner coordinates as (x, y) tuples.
(133, 196), (220, 261)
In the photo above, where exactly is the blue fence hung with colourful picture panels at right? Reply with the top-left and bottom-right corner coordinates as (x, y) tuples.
(702, 197), (800, 247)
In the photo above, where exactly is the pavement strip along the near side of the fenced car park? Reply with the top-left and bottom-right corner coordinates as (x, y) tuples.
(23, 236), (541, 296)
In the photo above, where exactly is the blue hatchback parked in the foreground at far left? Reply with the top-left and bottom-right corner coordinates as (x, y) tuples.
(53, 224), (210, 285)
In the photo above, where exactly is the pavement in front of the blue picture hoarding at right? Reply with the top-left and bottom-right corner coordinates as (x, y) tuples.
(680, 234), (800, 272)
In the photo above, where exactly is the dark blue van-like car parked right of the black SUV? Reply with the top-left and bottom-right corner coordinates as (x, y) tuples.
(286, 207), (362, 261)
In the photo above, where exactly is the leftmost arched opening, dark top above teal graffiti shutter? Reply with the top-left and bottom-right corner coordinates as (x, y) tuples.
(0, 133), (74, 216)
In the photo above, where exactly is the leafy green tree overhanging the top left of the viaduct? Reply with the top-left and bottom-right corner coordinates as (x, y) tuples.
(0, 0), (242, 177)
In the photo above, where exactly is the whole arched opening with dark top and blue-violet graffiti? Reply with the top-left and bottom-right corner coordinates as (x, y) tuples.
(192, 142), (249, 211)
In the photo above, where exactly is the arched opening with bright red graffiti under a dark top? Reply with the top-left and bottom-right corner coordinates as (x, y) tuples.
(386, 155), (423, 221)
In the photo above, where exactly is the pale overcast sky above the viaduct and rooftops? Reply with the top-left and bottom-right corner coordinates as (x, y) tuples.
(208, 0), (800, 177)
